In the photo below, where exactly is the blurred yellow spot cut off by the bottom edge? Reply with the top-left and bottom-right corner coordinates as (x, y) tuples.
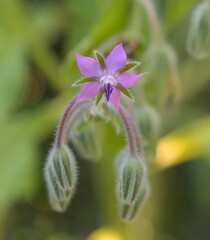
(87, 228), (123, 240)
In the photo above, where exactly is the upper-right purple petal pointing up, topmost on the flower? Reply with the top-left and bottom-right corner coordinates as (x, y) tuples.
(105, 43), (127, 75)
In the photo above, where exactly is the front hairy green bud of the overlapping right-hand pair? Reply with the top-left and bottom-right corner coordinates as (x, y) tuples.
(118, 157), (145, 204)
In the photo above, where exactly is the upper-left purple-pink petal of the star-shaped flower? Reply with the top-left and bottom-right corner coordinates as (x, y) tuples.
(76, 53), (103, 77)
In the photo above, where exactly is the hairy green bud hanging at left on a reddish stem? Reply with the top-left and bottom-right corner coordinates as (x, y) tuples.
(44, 146), (77, 212)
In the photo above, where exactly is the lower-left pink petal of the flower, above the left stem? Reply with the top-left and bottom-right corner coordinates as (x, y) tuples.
(75, 81), (100, 102)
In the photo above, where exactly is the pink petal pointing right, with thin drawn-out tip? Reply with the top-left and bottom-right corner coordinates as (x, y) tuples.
(117, 72), (148, 88)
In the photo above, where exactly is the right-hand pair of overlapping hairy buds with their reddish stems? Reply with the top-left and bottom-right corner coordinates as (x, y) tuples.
(115, 108), (149, 221)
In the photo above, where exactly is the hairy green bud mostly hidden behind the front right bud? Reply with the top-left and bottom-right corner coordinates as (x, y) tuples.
(120, 180), (150, 222)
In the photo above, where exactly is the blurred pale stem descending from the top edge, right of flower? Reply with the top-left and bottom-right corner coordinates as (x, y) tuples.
(139, 0), (164, 44)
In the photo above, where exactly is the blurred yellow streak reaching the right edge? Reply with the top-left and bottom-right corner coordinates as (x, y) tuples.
(156, 116), (210, 168)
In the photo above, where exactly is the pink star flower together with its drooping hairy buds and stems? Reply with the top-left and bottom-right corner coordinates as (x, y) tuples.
(44, 44), (151, 221)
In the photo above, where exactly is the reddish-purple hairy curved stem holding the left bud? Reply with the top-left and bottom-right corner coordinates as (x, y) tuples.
(55, 97), (77, 147)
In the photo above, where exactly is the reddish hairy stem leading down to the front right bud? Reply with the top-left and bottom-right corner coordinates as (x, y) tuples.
(119, 107), (136, 155)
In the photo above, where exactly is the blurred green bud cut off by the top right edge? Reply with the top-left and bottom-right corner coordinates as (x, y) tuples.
(187, 2), (210, 59)
